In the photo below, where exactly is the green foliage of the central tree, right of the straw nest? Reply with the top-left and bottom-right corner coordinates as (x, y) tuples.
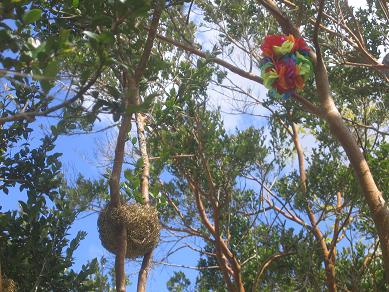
(142, 57), (322, 291)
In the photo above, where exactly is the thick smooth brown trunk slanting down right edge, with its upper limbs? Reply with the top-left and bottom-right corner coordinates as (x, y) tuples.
(255, 0), (389, 284)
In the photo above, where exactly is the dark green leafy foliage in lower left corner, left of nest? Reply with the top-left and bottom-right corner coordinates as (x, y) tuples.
(0, 137), (104, 291)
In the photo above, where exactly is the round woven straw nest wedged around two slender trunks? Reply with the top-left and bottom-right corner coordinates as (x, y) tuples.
(97, 204), (161, 258)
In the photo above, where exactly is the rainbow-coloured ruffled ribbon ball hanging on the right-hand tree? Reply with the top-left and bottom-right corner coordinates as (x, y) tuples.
(260, 35), (313, 98)
